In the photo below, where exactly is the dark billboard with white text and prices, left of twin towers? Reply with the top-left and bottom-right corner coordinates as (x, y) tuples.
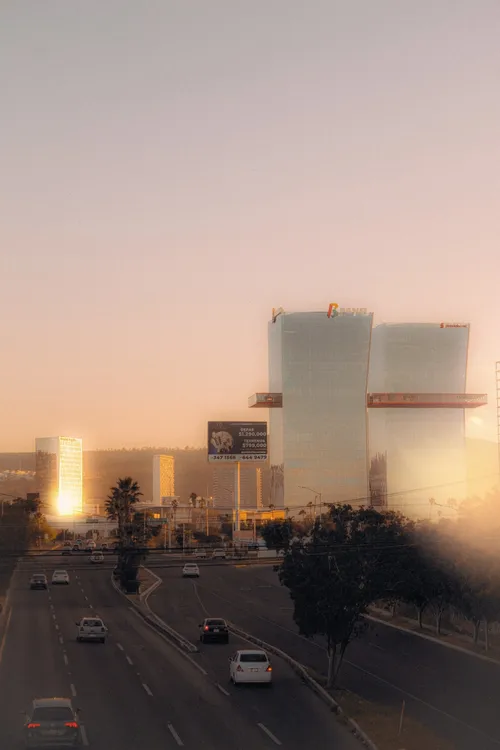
(208, 422), (267, 463)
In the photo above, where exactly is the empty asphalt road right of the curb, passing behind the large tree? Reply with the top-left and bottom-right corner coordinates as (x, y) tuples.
(149, 563), (500, 750)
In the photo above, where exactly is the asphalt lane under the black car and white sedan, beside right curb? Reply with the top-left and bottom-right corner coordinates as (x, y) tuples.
(149, 576), (360, 750)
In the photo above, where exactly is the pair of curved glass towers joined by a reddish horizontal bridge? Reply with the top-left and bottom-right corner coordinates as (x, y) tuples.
(249, 305), (487, 518)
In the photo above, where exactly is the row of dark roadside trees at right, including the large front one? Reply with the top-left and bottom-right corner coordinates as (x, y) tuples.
(261, 495), (500, 687)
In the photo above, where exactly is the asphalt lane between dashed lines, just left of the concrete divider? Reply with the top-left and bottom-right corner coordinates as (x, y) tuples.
(75, 570), (286, 750)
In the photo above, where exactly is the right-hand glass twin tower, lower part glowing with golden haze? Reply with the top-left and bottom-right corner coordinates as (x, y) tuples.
(368, 323), (469, 518)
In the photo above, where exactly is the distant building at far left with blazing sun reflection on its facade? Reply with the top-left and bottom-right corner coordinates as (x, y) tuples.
(35, 437), (83, 516)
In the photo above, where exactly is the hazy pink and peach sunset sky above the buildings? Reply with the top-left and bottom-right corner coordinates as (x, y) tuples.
(0, 0), (500, 450)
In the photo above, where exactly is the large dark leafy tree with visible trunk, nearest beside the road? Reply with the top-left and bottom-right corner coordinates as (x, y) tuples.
(279, 505), (407, 687)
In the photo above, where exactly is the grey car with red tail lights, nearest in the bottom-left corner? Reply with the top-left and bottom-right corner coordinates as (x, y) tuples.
(24, 698), (83, 748)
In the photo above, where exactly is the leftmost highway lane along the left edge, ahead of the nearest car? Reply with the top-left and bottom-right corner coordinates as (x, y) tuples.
(0, 569), (71, 750)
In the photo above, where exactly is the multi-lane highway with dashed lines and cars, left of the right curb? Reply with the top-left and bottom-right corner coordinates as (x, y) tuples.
(0, 555), (360, 750)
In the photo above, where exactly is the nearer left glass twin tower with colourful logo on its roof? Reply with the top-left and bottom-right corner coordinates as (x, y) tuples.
(268, 311), (373, 509)
